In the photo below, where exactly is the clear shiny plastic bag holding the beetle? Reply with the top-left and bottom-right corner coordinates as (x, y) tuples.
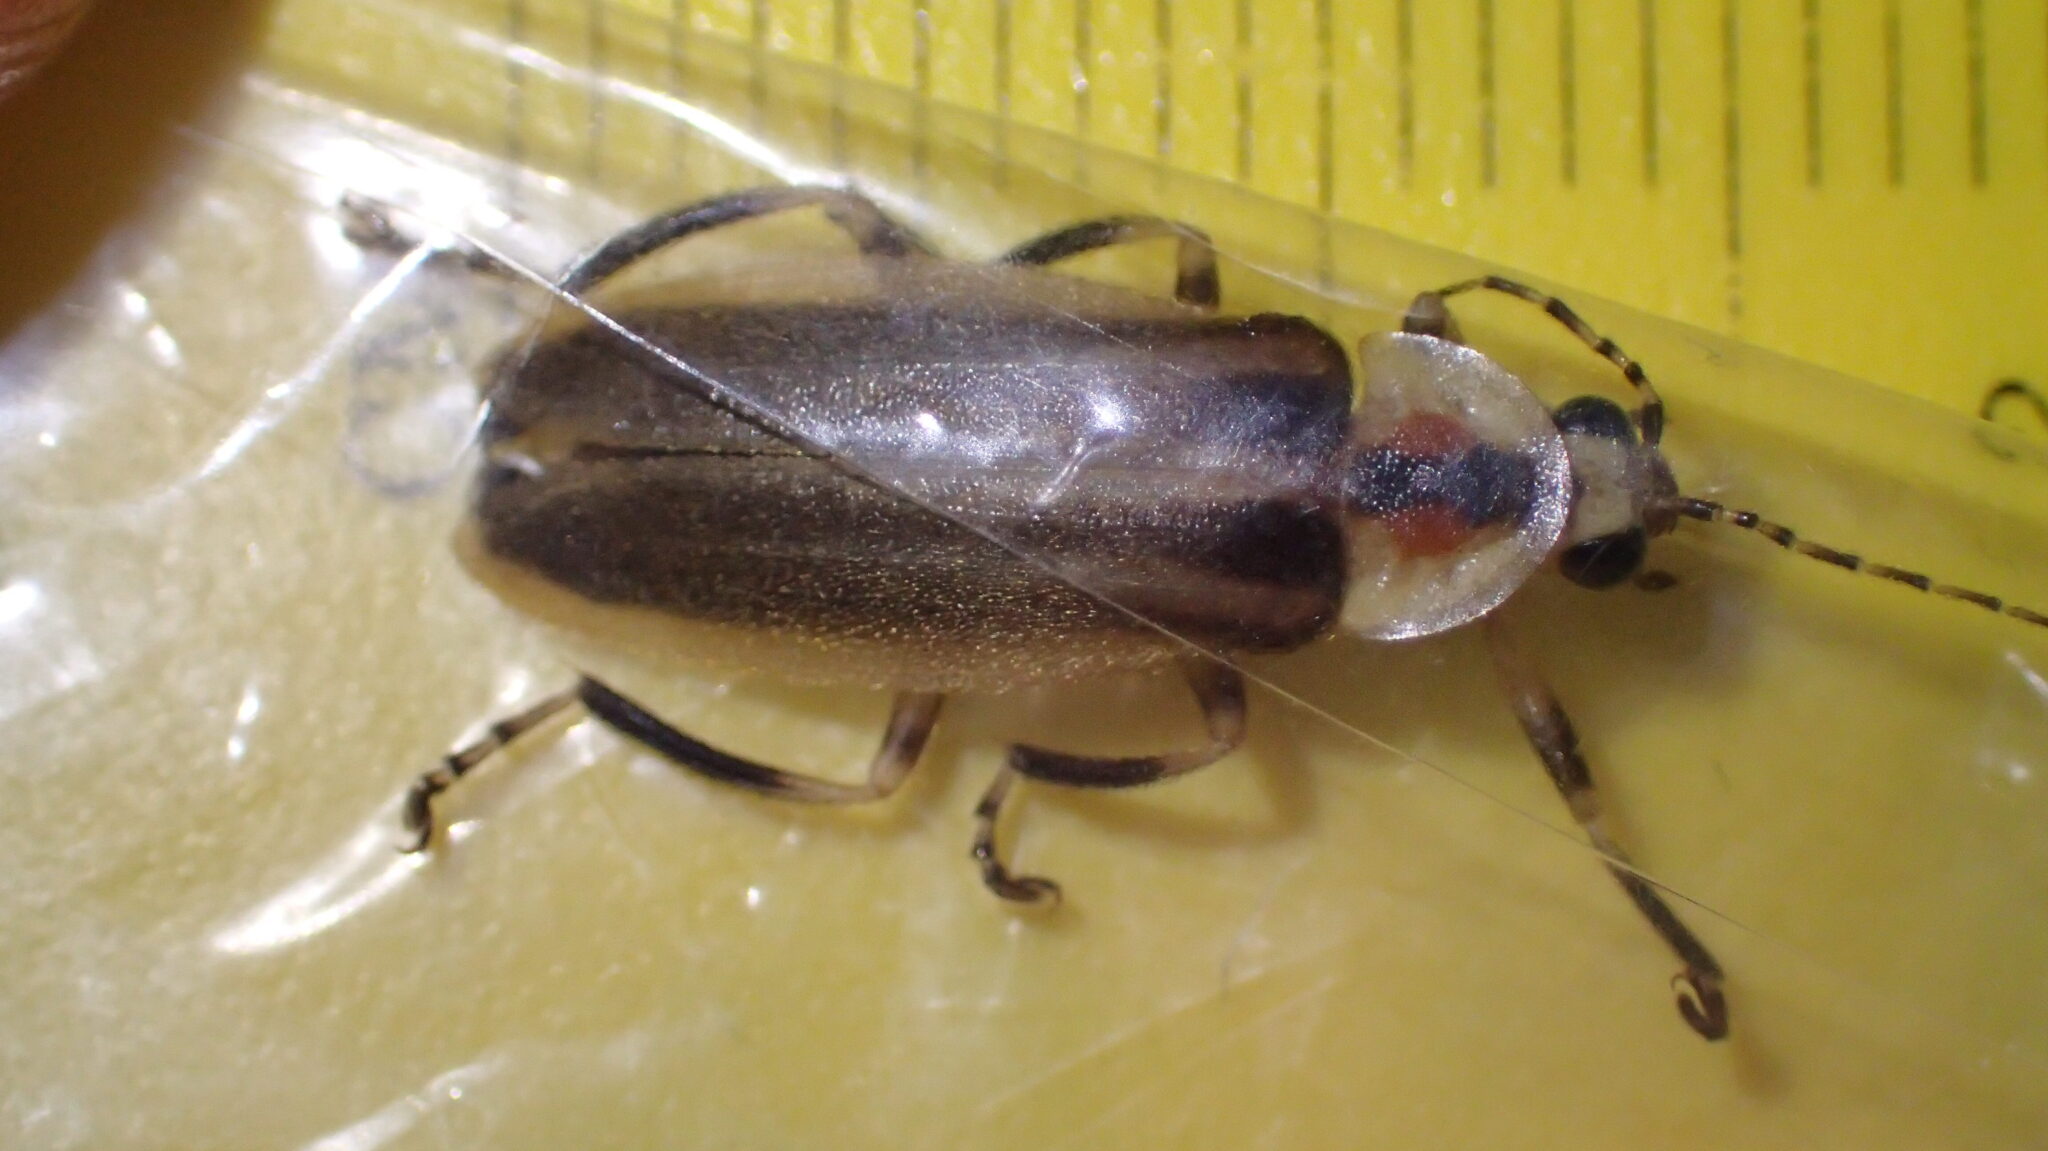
(0, 6), (2048, 1147)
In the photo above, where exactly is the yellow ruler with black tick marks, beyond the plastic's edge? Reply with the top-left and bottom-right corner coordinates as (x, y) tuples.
(260, 0), (2048, 419)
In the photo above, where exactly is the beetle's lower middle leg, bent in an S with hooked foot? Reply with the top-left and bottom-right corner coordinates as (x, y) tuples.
(973, 655), (1245, 903)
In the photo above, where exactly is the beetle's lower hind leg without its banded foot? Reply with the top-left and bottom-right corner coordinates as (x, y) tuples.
(575, 676), (946, 803)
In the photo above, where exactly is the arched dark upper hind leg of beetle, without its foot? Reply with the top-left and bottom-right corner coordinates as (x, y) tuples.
(559, 184), (932, 293)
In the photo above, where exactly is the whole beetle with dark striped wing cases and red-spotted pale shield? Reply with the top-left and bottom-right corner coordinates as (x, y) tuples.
(356, 186), (2048, 1040)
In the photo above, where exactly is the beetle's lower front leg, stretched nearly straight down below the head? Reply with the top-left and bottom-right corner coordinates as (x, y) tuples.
(1483, 616), (1729, 1038)
